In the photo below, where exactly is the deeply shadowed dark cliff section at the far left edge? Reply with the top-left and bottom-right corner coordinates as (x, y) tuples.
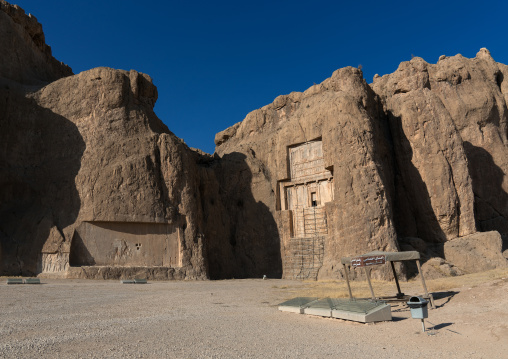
(0, 1), (76, 274)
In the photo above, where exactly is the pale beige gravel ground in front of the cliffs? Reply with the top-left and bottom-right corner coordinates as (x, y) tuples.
(0, 279), (508, 358)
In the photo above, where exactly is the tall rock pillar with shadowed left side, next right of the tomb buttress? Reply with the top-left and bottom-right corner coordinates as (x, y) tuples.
(372, 58), (476, 242)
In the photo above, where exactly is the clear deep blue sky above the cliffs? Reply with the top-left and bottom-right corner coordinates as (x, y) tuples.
(10, 0), (508, 153)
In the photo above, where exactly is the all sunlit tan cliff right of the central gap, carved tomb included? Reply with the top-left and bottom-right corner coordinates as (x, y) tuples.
(215, 49), (508, 277)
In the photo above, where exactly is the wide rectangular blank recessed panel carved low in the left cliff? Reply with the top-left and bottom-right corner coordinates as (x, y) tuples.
(70, 222), (181, 267)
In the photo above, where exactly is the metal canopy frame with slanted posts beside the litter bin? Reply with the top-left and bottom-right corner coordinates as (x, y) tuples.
(340, 251), (435, 308)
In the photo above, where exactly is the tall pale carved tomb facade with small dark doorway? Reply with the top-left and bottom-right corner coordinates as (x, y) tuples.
(279, 139), (333, 279)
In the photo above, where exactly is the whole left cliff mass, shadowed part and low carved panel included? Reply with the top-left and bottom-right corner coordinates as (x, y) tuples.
(0, 2), (208, 279)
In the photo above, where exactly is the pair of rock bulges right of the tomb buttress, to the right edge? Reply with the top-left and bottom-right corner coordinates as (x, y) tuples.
(372, 49), (508, 242)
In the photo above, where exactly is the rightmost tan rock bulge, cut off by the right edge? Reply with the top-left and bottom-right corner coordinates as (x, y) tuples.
(432, 49), (508, 242)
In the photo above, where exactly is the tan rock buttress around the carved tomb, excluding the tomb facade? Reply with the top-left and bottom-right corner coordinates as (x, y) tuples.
(216, 68), (397, 277)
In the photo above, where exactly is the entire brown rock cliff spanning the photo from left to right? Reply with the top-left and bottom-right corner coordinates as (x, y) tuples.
(0, 0), (508, 279)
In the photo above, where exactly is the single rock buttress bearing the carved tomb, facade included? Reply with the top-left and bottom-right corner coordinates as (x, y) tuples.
(216, 68), (397, 278)
